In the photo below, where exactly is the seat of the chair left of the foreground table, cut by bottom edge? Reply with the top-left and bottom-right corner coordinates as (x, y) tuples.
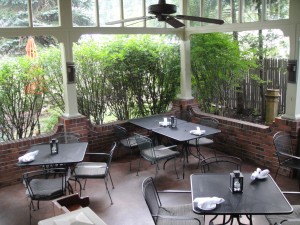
(156, 204), (204, 225)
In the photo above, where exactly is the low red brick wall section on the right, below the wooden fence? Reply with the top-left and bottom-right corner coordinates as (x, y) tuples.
(192, 108), (300, 175)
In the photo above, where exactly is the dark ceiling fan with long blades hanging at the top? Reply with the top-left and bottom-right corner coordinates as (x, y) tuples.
(106, 0), (224, 28)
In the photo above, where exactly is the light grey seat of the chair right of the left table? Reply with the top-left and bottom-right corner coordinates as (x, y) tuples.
(75, 162), (107, 178)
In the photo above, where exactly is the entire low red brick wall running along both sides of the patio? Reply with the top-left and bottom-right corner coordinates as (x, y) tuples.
(0, 104), (300, 188)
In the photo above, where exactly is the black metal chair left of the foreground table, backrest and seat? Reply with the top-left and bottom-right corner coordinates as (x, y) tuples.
(142, 177), (204, 225)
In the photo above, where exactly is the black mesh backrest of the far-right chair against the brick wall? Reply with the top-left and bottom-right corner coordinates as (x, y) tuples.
(273, 131), (294, 163)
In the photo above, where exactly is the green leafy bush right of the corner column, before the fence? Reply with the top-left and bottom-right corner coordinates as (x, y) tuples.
(191, 33), (254, 112)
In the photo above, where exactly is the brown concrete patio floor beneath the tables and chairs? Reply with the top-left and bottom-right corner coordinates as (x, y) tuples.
(0, 147), (300, 225)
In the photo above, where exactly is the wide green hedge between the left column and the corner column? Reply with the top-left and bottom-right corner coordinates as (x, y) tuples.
(74, 35), (180, 124)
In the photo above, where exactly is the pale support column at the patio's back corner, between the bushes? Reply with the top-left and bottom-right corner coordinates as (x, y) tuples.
(177, 35), (193, 99)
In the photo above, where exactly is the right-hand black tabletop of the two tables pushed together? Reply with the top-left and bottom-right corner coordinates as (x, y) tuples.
(153, 122), (221, 142)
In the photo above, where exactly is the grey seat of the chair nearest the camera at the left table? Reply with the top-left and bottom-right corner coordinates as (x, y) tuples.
(26, 177), (65, 200)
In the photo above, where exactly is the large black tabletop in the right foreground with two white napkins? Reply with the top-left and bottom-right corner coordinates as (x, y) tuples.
(191, 173), (293, 215)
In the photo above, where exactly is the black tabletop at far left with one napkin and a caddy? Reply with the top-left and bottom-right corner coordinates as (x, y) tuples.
(18, 142), (88, 166)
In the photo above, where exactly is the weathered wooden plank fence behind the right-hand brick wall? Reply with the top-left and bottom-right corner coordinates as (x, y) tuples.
(225, 59), (288, 114)
